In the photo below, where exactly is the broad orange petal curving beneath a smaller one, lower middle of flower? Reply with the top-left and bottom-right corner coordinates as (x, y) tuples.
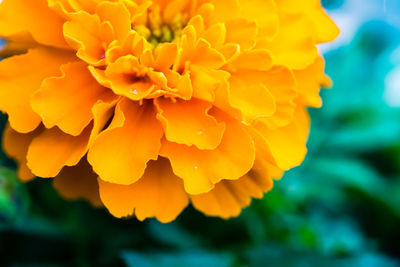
(160, 110), (255, 195)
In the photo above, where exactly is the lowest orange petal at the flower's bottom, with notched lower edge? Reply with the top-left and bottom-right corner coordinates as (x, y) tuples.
(99, 158), (188, 223)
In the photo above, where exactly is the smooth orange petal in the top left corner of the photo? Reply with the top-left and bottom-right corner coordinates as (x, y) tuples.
(0, 0), (68, 48)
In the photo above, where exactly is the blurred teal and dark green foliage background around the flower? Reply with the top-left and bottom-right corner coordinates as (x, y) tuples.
(0, 0), (400, 267)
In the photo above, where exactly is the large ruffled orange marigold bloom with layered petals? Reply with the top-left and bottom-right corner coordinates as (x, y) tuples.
(0, 0), (338, 222)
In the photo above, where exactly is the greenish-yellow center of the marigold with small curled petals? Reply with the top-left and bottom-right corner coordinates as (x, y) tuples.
(134, 6), (188, 47)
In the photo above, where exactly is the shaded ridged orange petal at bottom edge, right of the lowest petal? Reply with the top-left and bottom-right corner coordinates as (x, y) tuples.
(190, 171), (273, 219)
